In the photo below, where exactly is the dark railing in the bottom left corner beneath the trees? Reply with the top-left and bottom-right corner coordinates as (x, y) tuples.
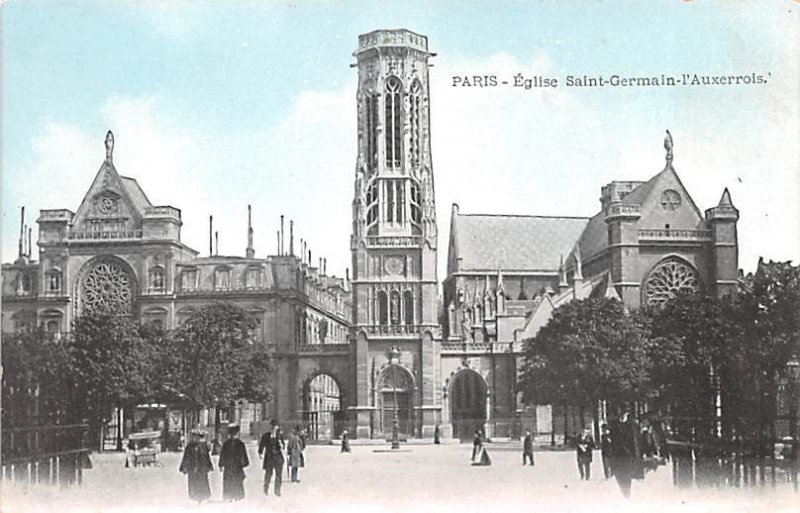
(2, 424), (91, 486)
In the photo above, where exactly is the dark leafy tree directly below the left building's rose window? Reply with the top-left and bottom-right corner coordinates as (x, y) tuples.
(67, 312), (147, 441)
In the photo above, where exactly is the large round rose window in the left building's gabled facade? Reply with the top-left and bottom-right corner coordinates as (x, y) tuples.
(81, 262), (133, 312)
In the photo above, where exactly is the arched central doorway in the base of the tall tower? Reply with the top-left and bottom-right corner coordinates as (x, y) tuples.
(377, 364), (414, 438)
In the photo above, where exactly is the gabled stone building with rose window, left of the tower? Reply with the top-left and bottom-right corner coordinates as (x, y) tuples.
(2, 132), (354, 436)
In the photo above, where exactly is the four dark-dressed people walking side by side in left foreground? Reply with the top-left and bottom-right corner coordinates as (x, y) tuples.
(179, 420), (306, 502)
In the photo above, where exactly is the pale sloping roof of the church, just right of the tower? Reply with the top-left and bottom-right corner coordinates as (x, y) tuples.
(451, 214), (588, 271)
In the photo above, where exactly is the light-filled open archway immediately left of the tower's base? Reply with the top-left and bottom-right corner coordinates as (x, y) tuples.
(303, 373), (342, 440)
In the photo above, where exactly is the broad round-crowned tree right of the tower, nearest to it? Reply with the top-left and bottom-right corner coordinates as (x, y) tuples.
(521, 298), (649, 426)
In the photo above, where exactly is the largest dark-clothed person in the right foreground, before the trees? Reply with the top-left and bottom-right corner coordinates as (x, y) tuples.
(609, 407), (644, 498)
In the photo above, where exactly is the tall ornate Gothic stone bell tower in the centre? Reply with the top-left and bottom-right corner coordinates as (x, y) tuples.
(350, 29), (441, 438)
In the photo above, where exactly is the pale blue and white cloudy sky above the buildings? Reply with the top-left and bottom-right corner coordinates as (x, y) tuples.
(2, 0), (800, 277)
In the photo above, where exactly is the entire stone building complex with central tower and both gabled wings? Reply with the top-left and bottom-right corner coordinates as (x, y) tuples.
(2, 29), (739, 439)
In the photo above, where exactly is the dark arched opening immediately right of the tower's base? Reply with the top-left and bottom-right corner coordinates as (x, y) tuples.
(449, 369), (486, 440)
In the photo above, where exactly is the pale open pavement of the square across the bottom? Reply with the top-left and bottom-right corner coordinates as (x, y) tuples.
(2, 442), (800, 513)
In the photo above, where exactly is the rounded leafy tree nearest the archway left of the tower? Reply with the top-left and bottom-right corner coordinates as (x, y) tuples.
(164, 303), (271, 438)
